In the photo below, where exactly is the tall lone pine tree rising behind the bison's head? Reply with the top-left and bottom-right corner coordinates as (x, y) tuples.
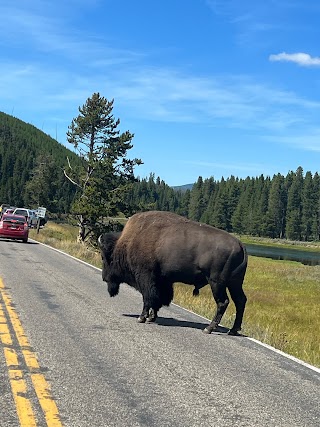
(65, 93), (142, 242)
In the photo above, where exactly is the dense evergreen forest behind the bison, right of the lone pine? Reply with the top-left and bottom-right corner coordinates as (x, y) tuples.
(132, 167), (320, 241)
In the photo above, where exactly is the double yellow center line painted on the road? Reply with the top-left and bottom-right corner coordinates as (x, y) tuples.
(0, 277), (62, 427)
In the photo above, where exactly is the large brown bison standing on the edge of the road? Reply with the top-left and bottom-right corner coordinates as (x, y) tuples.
(98, 211), (248, 335)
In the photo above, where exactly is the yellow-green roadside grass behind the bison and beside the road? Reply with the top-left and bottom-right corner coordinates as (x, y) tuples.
(30, 221), (320, 367)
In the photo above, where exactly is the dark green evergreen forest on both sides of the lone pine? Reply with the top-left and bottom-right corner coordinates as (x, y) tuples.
(0, 112), (320, 241)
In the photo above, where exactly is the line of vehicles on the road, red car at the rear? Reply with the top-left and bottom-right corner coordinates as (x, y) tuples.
(0, 204), (46, 243)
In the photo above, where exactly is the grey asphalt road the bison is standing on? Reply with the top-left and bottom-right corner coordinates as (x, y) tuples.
(0, 241), (320, 427)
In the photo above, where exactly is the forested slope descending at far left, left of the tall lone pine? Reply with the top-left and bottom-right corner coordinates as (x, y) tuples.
(0, 112), (80, 213)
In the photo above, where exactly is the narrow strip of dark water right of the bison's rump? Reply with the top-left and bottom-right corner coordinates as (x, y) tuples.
(245, 243), (320, 265)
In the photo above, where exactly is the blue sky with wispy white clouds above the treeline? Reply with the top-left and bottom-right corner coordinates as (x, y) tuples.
(0, 0), (320, 185)
